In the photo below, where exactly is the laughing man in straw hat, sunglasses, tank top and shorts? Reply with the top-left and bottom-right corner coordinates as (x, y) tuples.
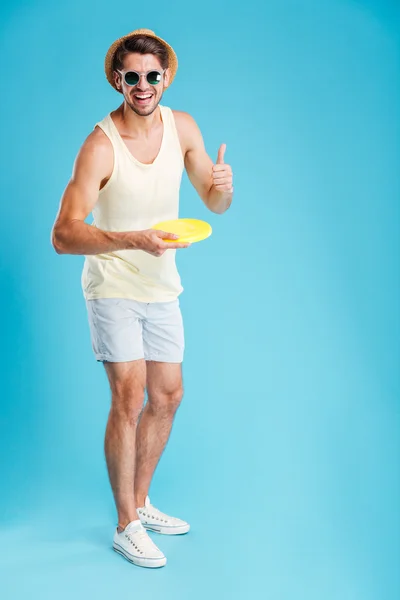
(52, 29), (233, 567)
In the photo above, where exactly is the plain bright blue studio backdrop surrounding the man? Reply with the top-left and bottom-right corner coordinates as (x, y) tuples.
(0, 0), (400, 600)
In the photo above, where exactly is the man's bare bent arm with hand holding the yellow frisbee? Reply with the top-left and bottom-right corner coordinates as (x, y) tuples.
(51, 128), (188, 256)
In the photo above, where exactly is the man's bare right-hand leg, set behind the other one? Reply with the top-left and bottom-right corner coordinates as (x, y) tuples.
(134, 361), (183, 508)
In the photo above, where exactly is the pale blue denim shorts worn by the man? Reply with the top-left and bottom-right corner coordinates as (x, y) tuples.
(86, 298), (185, 363)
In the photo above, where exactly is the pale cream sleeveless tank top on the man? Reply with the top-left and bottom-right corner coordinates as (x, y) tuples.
(81, 105), (184, 302)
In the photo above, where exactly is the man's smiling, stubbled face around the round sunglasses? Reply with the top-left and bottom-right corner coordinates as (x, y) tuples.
(114, 53), (168, 117)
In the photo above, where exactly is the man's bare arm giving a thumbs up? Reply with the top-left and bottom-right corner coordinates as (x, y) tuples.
(174, 111), (233, 214)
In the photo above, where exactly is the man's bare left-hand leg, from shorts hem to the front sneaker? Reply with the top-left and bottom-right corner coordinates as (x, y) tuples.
(104, 359), (146, 531)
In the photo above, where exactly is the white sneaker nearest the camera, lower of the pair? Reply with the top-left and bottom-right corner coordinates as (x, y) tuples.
(113, 519), (167, 567)
